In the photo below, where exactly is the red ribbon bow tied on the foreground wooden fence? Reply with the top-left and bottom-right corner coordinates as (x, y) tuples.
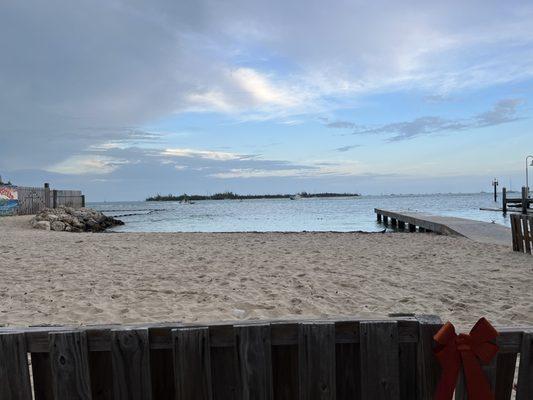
(433, 318), (498, 400)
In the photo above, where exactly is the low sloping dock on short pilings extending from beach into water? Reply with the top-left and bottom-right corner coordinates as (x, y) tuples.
(374, 208), (512, 246)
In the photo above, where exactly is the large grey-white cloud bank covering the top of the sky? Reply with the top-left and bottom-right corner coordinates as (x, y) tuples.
(0, 0), (533, 169)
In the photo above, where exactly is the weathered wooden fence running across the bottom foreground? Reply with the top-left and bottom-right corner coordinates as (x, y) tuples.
(0, 316), (533, 400)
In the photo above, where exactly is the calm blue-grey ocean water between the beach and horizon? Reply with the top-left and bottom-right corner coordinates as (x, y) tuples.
(88, 193), (510, 232)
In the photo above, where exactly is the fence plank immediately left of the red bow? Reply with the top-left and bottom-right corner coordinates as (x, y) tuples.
(416, 315), (442, 400)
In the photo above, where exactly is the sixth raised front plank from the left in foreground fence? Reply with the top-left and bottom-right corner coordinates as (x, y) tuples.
(298, 322), (336, 400)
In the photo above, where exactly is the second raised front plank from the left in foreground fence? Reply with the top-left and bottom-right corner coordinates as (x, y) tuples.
(50, 331), (92, 400)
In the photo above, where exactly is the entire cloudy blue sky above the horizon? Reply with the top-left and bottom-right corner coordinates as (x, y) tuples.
(0, 0), (533, 201)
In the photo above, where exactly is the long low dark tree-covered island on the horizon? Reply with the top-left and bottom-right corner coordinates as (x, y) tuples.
(146, 192), (360, 202)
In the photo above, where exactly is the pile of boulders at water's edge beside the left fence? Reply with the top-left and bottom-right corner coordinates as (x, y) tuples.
(31, 206), (124, 232)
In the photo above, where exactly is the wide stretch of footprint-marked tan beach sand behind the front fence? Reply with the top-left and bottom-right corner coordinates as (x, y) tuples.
(0, 217), (533, 329)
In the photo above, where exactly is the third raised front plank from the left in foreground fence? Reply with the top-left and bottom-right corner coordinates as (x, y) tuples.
(111, 329), (152, 400)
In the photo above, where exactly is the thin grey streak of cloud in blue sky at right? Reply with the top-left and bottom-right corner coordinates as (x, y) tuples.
(326, 99), (525, 141)
